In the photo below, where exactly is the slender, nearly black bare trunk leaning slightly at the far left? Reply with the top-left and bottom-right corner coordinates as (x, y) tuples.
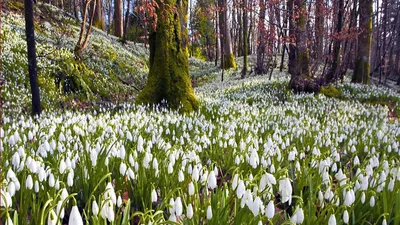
(25, 0), (42, 115)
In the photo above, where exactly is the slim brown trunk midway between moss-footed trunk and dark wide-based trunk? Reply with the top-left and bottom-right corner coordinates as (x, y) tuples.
(255, 0), (266, 74)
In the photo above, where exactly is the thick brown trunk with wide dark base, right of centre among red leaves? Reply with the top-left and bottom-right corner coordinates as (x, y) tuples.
(289, 0), (319, 92)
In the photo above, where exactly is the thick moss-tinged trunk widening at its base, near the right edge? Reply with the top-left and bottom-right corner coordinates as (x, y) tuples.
(351, 0), (373, 84)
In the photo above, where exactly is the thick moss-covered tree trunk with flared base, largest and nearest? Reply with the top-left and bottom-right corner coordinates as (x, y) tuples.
(137, 0), (199, 112)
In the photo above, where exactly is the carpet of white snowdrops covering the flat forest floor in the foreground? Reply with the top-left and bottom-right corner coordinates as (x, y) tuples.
(0, 73), (400, 225)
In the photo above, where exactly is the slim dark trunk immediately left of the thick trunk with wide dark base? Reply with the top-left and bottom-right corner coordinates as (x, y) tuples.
(287, 0), (296, 75)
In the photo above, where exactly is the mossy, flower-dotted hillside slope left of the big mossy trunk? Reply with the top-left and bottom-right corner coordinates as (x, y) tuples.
(2, 1), (148, 111)
